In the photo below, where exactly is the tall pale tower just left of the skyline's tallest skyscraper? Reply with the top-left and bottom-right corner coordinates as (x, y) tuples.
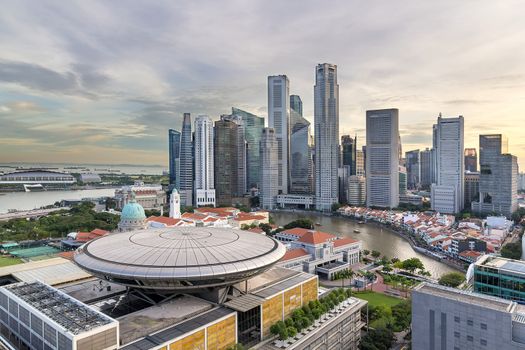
(268, 75), (290, 194)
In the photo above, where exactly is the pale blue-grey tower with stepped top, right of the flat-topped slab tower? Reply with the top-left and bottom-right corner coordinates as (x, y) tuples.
(431, 114), (465, 214)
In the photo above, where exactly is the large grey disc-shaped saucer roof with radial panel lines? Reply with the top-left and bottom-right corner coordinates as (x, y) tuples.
(74, 227), (286, 291)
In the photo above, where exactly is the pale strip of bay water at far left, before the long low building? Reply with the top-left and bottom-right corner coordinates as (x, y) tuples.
(0, 188), (115, 213)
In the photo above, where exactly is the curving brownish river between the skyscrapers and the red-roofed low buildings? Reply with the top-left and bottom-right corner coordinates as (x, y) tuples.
(272, 212), (455, 278)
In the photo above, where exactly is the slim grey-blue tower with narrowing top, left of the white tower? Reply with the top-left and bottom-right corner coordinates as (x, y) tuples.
(179, 113), (193, 206)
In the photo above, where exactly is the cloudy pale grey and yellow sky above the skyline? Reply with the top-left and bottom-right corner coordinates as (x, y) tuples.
(0, 0), (525, 168)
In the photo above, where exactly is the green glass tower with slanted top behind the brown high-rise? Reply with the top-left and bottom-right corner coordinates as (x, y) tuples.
(232, 107), (264, 190)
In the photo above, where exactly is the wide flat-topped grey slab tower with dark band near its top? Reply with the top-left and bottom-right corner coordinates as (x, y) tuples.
(365, 109), (399, 208)
